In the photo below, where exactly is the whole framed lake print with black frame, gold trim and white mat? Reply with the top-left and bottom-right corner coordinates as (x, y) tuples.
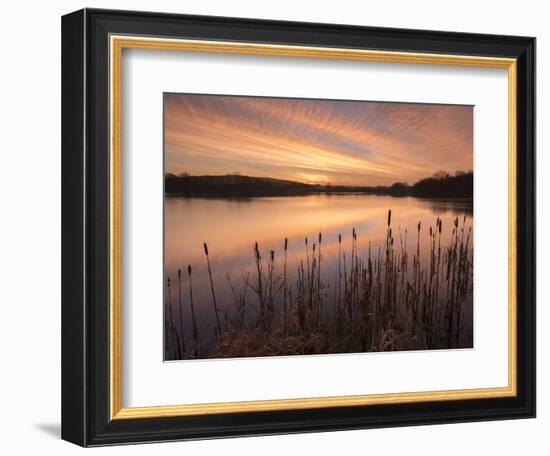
(62, 9), (535, 446)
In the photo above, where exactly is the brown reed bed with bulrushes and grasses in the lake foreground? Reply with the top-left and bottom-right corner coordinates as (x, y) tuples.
(165, 210), (473, 360)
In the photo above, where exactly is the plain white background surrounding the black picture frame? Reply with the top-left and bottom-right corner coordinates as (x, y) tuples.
(0, 0), (550, 456)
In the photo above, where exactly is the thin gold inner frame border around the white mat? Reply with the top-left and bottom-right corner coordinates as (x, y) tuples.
(109, 35), (517, 420)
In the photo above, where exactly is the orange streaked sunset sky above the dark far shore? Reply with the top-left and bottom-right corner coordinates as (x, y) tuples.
(164, 94), (473, 185)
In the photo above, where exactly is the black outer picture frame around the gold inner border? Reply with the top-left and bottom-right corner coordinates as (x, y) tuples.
(62, 9), (536, 446)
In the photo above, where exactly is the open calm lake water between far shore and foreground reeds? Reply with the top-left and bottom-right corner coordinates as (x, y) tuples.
(165, 195), (473, 358)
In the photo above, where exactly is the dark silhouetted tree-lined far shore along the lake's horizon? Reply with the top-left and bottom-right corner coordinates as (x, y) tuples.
(164, 171), (474, 199)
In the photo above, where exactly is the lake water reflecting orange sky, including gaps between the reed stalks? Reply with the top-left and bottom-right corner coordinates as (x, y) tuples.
(164, 194), (473, 359)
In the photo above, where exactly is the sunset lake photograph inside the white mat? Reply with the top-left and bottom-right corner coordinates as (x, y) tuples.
(163, 93), (474, 361)
